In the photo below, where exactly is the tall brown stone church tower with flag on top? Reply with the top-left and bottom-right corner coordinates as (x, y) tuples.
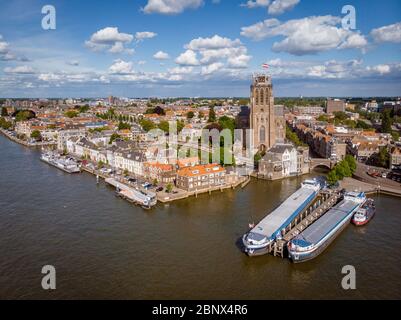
(250, 74), (276, 152)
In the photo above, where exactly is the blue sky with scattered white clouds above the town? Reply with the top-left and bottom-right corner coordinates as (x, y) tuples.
(0, 0), (401, 97)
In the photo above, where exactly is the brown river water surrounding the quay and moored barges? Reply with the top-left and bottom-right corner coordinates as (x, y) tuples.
(0, 136), (401, 299)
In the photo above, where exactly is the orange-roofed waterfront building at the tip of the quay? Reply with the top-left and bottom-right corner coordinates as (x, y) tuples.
(177, 164), (226, 192)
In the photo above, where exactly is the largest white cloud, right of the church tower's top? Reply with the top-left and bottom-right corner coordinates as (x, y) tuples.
(241, 16), (368, 55)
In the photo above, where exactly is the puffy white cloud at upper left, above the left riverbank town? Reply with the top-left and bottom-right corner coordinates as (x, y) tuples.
(85, 27), (134, 54)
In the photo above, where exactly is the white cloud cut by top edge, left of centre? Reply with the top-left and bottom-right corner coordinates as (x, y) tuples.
(142, 0), (203, 14)
